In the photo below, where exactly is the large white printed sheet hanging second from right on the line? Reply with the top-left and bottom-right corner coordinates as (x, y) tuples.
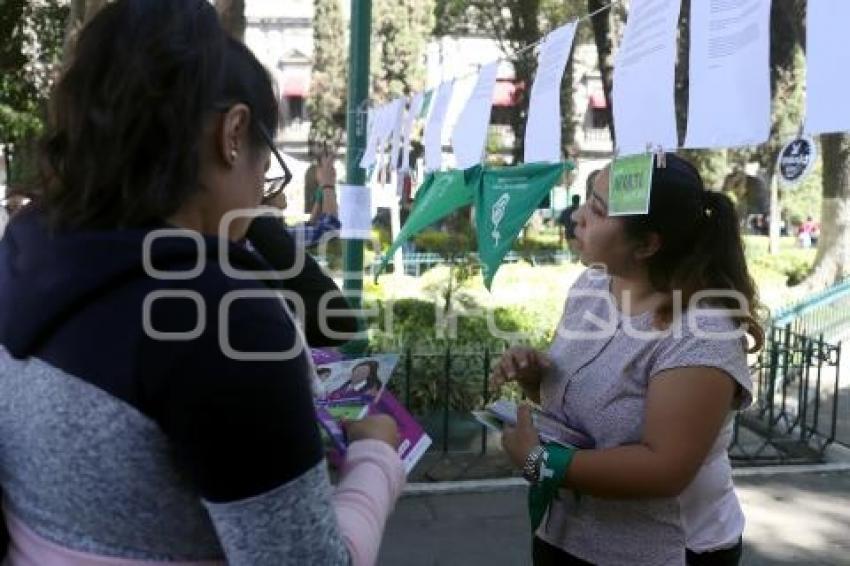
(685, 0), (770, 148)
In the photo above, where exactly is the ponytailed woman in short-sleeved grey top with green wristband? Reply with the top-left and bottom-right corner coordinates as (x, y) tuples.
(493, 154), (764, 566)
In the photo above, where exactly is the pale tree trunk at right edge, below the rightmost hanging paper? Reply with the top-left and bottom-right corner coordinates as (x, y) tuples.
(802, 134), (850, 290)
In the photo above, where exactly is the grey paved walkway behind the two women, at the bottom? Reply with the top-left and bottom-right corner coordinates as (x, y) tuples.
(379, 472), (850, 566)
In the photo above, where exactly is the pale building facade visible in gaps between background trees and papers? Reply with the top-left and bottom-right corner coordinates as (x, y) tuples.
(245, 0), (613, 209)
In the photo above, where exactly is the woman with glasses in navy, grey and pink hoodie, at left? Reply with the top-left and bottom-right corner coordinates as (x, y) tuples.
(0, 0), (404, 566)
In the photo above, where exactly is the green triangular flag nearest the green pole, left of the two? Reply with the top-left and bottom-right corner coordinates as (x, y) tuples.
(375, 165), (481, 280)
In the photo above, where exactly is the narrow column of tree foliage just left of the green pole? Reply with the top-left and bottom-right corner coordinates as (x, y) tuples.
(307, 0), (348, 147)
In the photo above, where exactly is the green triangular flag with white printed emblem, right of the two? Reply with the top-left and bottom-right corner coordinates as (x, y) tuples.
(475, 163), (572, 289)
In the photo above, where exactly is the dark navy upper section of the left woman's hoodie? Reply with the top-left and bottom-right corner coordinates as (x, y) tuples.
(0, 208), (322, 502)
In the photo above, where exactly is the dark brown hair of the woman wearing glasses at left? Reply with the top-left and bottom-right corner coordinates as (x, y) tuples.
(32, 0), (277, 228)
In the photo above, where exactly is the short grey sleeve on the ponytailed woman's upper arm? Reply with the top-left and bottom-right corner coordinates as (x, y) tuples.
(650, 309), (753, 409)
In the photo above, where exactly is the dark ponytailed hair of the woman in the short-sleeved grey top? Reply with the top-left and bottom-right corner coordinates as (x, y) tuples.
(623, 153), (764, 351)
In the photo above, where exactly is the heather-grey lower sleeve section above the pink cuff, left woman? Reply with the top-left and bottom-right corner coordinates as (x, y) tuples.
(204, 460), (350, 566)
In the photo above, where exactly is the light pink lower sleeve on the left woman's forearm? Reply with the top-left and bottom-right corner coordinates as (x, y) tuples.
(333, 440), (405, 566)
